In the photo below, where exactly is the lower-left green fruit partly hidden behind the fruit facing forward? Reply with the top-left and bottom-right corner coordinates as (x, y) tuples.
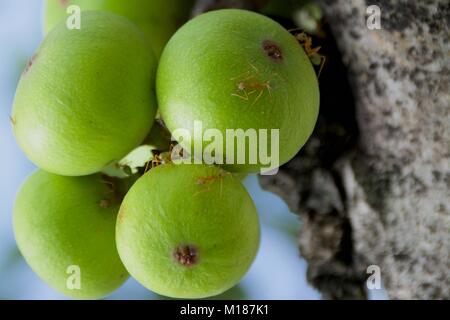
(13, 170), (128, 299)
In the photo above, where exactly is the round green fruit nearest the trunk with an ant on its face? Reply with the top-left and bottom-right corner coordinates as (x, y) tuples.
(156, 9), (319, 172)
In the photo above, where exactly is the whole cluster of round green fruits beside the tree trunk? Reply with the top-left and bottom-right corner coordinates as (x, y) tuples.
(11, 0), (319, 298)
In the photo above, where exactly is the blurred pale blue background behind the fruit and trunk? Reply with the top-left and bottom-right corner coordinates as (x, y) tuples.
(0, 0), (328, 299)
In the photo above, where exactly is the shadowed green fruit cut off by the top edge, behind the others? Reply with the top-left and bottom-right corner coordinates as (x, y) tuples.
(44, 0), (193, 57)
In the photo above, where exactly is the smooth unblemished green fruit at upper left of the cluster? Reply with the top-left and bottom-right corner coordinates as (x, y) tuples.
(12, 11), (156, 176)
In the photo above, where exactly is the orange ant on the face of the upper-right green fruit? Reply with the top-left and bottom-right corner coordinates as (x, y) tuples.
(231, 62), (279, 105)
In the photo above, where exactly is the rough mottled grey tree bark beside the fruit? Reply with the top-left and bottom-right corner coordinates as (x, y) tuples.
(260, 0), (450, 299)
